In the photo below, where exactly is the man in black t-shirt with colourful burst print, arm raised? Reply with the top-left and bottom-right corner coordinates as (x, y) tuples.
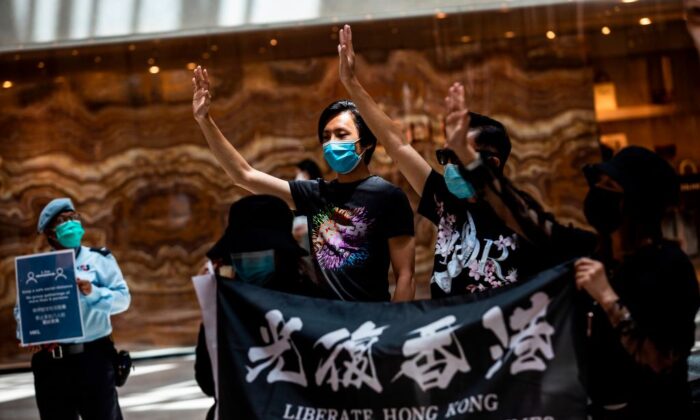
(192, 67), (415, 301)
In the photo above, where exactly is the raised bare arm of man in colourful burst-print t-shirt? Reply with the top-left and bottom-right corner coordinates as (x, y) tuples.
(192, 67), (294, 208)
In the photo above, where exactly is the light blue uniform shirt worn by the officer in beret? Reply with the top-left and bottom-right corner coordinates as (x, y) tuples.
(15, 246), (131, 343)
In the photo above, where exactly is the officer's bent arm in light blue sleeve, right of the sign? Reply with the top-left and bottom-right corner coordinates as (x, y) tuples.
(81, 254), (131, 315)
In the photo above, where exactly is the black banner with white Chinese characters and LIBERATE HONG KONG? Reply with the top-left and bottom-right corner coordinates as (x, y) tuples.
(218, 266), (586, 420)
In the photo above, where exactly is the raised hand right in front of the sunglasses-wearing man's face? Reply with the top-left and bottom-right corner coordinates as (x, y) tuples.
(445, 82), (477, 165)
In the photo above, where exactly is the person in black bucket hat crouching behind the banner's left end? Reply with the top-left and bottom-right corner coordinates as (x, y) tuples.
(194, 195), (327, 419)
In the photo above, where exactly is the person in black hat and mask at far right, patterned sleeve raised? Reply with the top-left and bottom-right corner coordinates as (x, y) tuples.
(448, 132), (700, 419)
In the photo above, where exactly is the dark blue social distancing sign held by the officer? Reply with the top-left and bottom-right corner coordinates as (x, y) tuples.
(15, 249), (83, 346)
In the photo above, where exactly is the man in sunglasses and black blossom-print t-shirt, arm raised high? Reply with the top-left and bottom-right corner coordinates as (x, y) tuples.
(338, 25), (535, 298)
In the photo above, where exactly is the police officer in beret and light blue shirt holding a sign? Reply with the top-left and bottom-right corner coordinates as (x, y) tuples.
(15, 198), (131, 420)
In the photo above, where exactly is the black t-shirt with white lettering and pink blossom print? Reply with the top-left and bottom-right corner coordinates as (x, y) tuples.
(418, 171), (541, 298)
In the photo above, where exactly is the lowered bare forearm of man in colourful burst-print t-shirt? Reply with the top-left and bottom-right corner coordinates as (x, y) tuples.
(389, 236), (416, 302)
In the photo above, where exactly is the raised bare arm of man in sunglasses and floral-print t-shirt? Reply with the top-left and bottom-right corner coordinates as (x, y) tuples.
(338, 25), (431, 195)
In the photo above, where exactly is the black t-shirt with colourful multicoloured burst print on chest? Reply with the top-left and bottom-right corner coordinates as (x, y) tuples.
(289, 176), (413, 301)
